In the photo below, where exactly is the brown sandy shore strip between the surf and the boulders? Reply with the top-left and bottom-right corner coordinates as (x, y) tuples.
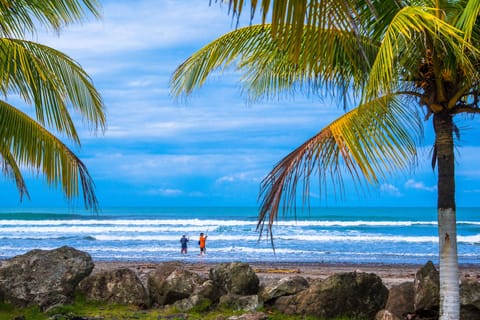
(93, 261), (480, 287)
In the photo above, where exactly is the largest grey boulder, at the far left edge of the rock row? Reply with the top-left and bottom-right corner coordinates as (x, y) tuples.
(0, 246), (94, 310)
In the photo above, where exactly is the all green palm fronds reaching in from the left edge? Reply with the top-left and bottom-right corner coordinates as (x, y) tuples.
(0, 0), (105, 209)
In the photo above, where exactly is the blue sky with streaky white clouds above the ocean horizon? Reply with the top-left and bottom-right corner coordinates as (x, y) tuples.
(0, 0), (480, 208)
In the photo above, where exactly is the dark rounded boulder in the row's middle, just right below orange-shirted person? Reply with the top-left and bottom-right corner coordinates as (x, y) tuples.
(209, 262), (260, 295)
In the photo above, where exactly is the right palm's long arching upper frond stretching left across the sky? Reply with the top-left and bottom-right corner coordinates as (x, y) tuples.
(171, 24), (377, 99)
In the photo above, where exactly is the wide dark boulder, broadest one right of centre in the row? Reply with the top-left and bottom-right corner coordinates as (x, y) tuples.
(274, 272), (388, 319)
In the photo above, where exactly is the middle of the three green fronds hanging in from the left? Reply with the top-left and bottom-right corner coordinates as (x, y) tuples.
(0, 38), (105, 142)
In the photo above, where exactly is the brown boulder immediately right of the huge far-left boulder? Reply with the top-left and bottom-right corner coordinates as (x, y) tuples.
(78, 268), (149, 307)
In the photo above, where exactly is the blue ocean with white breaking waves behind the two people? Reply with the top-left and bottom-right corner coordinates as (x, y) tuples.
(0, 207), (480, 265)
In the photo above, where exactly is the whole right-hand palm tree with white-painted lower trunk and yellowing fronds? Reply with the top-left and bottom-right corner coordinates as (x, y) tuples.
(171, 0), (480, 319)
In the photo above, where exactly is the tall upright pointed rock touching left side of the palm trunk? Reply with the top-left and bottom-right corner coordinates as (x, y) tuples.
(413, 261), (440, 318)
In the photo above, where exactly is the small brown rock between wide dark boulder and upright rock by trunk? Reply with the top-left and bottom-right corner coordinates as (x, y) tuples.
(385, 282), (415, 319)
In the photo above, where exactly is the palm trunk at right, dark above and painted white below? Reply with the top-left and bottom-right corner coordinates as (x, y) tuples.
(434, 113), (460, 320)
